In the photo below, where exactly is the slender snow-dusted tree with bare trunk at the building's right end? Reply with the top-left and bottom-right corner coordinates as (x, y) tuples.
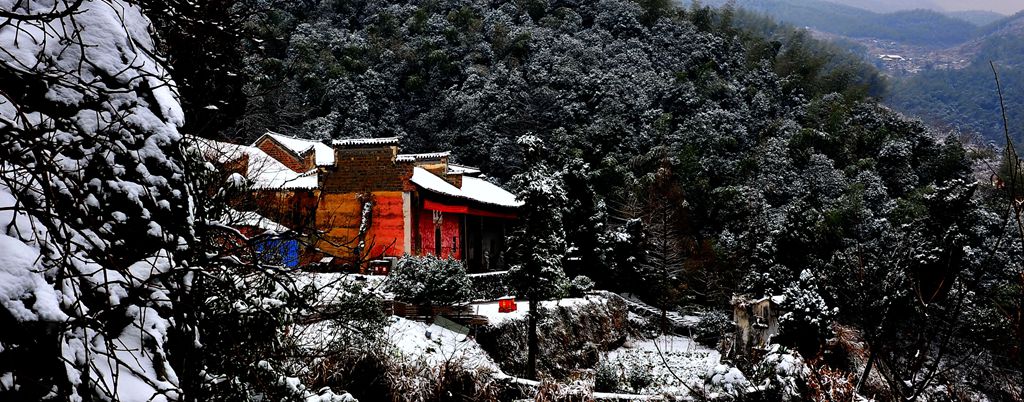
(508, 135), (567, 377)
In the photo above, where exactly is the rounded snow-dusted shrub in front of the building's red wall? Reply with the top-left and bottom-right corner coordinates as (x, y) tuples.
(387, 256), (473, 306)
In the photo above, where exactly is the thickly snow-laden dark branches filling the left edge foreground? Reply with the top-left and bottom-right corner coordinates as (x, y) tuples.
(0, 0), (191, 401)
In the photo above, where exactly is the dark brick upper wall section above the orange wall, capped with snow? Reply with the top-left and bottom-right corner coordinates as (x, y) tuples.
(321, 146), (413, 193)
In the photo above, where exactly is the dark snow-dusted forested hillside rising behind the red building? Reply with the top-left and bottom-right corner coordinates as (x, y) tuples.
(220, 0), (1021, 398)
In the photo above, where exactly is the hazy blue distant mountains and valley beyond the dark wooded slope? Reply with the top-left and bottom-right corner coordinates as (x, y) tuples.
(706, 0), (1024, 143)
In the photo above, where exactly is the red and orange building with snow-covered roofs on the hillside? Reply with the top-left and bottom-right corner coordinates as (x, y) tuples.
(199, 133), (520, 271)
